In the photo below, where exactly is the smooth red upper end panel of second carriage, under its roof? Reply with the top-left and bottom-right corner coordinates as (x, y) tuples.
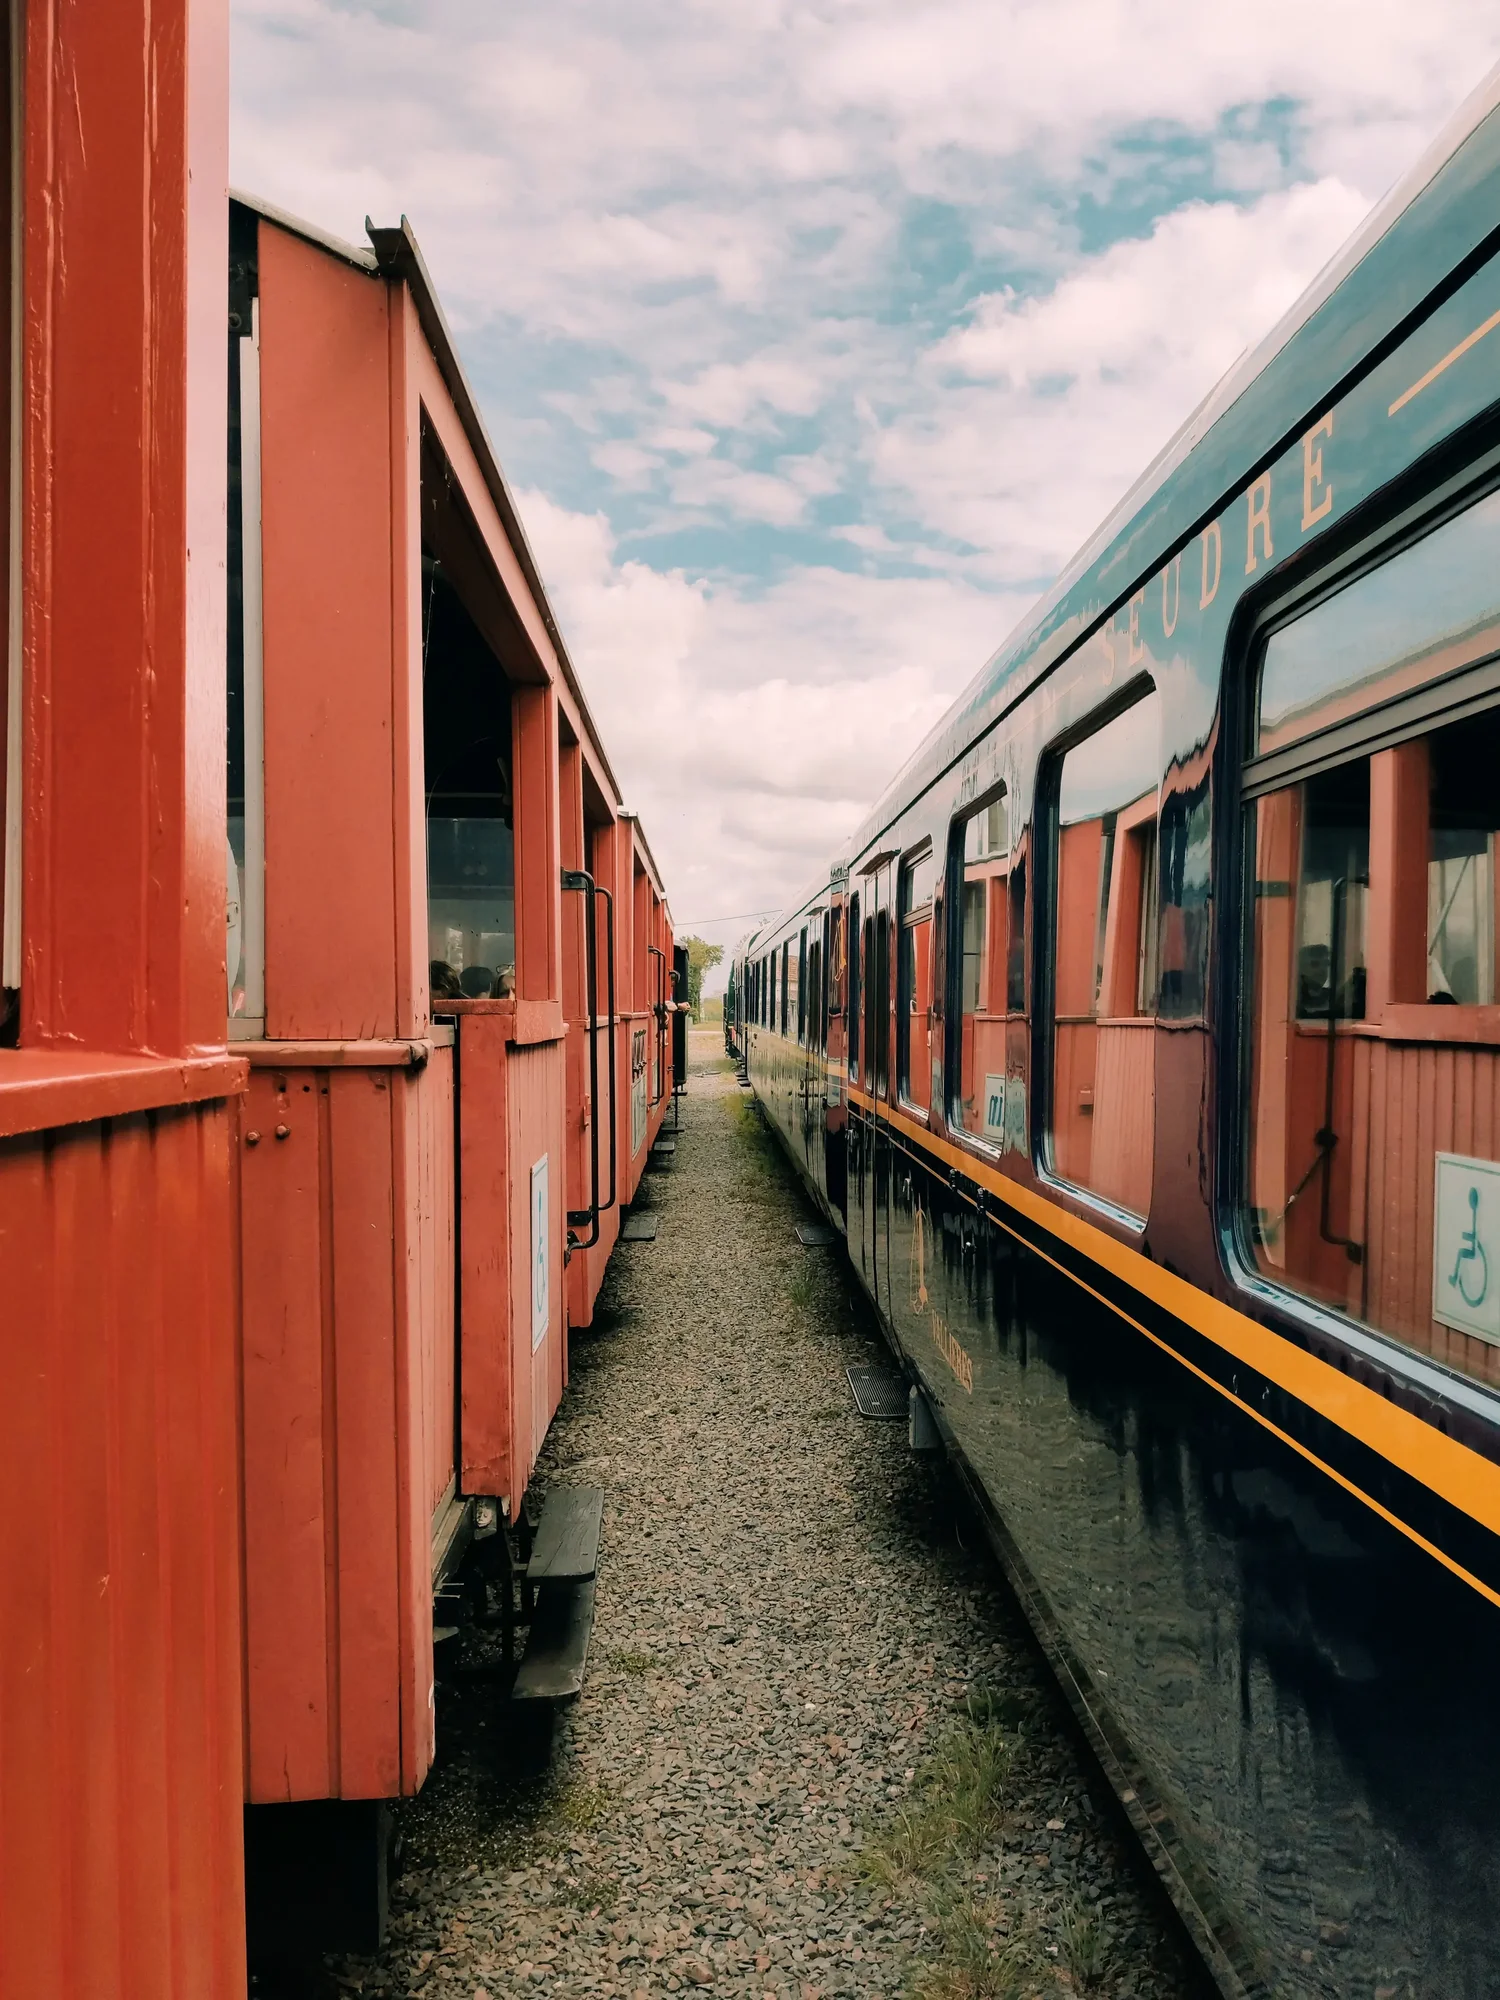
(258, 224), (400, 1040)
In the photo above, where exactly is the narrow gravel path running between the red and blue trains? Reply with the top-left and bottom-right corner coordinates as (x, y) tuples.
(334, 1034), (1198, 2000)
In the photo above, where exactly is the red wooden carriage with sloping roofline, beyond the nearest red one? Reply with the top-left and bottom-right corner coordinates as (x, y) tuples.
(228, 202), (670, 1942)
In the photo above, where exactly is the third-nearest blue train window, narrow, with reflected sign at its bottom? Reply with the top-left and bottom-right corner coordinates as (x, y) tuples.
(948, 792), (1010, 1144)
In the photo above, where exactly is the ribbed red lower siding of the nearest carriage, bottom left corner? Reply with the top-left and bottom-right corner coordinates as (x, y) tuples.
(0, 1104), (244, 2000)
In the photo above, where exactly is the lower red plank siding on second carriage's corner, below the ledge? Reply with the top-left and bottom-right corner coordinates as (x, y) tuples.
(240, 1050), (454, 1804)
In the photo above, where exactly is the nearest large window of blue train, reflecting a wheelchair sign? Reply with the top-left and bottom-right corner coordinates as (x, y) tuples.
(1242, 484), (1500, 1384)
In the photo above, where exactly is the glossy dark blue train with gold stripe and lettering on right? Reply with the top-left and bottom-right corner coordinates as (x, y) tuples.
(740, 72), (1500, 2000)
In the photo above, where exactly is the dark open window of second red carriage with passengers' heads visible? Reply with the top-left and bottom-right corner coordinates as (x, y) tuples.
(422, 562), (516, 1000)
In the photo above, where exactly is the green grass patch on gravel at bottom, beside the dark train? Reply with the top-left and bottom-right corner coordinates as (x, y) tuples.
(860, 1690), (1110, 2000)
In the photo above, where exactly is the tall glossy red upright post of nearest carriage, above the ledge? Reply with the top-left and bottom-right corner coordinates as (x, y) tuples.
(22, 0), (228, 1054)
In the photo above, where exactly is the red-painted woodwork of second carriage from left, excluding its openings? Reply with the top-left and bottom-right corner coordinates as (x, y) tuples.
(238, 191), (670, 1832)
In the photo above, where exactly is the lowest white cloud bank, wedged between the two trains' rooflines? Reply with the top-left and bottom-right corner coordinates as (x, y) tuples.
(518, 492), (1026, 916)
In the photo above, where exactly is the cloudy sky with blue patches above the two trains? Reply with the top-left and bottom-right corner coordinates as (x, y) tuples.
(232, 0), (1500, 968)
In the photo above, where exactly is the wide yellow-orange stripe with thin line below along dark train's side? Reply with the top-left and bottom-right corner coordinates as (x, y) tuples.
(848, 1084), (1500, 1604)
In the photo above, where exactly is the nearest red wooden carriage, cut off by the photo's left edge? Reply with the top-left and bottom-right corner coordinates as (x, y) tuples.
(0, 0), (244, 2000)
